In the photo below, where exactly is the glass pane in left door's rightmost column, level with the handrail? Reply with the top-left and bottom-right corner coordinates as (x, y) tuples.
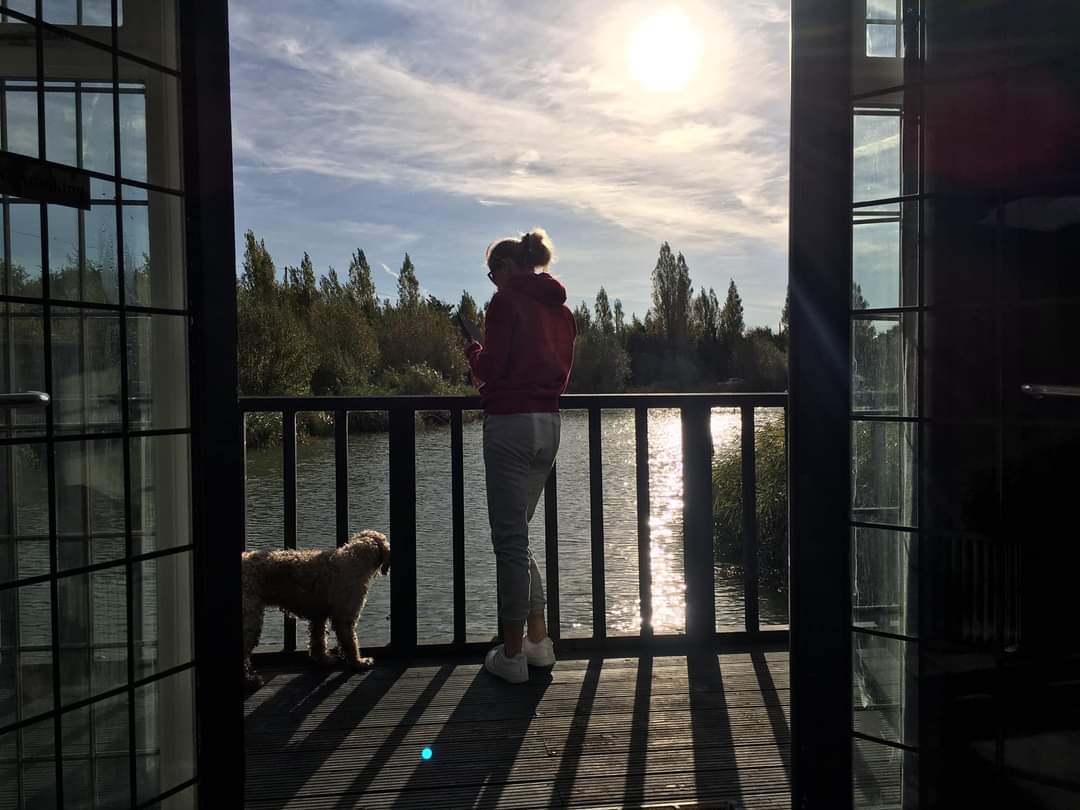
(127, 314), (190, 432)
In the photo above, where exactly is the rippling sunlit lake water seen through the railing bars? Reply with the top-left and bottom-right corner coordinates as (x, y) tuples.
(246, 408), (787, 650)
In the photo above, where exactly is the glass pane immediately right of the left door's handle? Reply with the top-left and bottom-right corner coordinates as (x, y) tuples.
(52, 308), (121, 433)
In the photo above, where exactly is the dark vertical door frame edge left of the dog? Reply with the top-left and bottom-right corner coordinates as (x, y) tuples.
(179, 0), (244, 808)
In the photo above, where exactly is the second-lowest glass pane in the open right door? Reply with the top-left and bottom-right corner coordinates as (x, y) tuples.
(851, 630), (919, 745)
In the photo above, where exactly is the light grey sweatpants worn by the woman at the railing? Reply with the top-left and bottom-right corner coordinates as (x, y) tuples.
(484, 414), (562, 622)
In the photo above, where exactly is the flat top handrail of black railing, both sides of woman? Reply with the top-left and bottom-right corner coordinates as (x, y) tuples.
(240, 391), (787, 414)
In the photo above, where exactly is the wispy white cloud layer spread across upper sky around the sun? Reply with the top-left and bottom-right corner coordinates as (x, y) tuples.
(231, 0), (787, 253)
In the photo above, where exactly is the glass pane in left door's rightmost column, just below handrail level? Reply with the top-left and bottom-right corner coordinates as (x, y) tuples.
(131, 435), (191, 554)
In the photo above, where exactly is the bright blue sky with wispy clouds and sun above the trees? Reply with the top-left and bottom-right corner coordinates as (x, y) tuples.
(230, 0), (788, 328)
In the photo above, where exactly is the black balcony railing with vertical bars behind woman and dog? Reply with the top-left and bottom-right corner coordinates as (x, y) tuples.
(240, 393), (787, 654)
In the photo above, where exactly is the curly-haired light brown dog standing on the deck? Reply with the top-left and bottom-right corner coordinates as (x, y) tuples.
(241, 530), (390, 688)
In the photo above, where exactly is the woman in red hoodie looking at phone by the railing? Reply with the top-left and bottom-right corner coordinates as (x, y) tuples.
(467, 229), (577, 684)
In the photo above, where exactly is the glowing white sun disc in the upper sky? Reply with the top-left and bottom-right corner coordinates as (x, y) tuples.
(626, 6), (705, 93)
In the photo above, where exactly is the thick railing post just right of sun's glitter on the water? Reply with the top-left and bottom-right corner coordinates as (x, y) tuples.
(683, 403), (716, 640)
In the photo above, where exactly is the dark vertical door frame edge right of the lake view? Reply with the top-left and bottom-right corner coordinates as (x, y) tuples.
(787, 0), (852, 810)
